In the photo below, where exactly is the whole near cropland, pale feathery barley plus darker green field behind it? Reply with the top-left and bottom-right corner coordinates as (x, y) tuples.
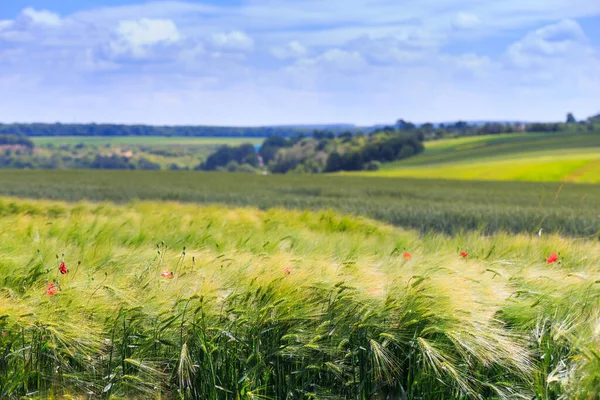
(0, 170), (600, 400)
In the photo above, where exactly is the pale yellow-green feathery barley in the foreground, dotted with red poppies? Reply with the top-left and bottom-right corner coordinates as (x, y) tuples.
(0, 199), (600, 399)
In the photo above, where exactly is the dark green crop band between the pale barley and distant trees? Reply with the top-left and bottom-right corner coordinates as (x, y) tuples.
(0, 170), (600, 237)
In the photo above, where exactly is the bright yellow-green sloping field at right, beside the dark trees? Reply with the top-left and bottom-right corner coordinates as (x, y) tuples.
(352, 132), (600, 183)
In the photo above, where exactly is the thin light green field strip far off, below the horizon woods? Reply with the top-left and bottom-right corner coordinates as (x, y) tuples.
(31, 136), (264, 146)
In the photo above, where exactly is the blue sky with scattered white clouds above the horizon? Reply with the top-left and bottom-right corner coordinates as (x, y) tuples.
(0, 0), (600, 126)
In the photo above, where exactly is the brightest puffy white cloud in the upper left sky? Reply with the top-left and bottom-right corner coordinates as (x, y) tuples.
(109, 18), (182, 57)
